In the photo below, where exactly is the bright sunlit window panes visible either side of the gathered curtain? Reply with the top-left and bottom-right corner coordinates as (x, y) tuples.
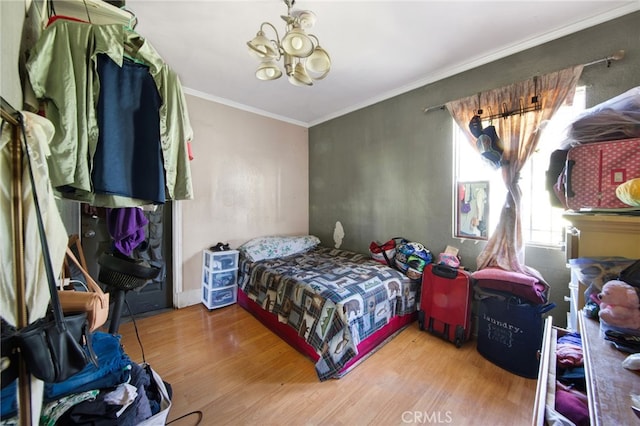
(453, 86), (585, 247)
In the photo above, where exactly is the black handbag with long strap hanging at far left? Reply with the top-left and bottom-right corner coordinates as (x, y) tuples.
(16, 115), (97, 383)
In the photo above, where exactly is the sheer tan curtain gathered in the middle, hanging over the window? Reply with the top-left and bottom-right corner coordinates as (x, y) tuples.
(446, 65), (583, 280)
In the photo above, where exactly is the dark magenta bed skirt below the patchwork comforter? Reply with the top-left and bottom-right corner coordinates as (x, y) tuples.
(238, 289), (418, 377)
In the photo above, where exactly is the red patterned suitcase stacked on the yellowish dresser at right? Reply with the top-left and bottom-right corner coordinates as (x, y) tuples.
(565, 139), (640, 211)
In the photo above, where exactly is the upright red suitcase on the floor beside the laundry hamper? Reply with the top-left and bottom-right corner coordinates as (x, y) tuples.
(418, 263), (472, 347)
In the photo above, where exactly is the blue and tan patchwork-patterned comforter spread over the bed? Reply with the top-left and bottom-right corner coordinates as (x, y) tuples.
(239, 247), (419, 380)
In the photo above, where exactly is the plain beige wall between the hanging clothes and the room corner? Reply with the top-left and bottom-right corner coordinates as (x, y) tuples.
(174, 95), (309, 307)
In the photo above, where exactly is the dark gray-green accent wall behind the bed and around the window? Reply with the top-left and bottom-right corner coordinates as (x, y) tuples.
(309, 12), (640, 325)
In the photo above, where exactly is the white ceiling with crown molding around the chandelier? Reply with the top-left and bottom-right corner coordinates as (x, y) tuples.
(126, 0), (640, 127)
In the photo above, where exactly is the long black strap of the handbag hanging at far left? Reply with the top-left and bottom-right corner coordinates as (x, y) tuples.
(17, 114), (66, 330)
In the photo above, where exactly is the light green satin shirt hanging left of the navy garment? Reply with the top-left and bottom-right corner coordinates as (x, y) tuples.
(26, 20), (124, 192)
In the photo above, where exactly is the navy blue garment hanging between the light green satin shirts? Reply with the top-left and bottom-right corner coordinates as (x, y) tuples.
(91, 54), (166, 204)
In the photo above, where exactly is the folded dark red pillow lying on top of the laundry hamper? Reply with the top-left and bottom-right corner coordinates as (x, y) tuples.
(471, 268), (547, 304)
